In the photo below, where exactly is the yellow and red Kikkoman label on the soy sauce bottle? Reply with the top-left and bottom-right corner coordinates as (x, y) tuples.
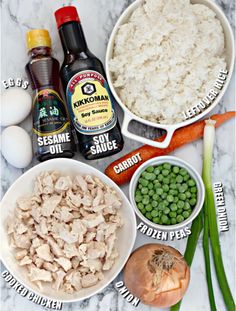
(66, 70), (116, 135)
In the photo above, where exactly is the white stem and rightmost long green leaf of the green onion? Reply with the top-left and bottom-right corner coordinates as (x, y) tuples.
(202, 120), (235, 311)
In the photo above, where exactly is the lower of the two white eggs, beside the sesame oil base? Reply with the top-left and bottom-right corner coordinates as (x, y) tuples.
(1, 126), (33, 168)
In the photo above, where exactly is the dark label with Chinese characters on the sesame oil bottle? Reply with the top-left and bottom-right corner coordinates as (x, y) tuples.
(33, 89), (71, 154)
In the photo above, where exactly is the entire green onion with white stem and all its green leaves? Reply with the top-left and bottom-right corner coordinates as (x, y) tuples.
(170, 119), (235, 311)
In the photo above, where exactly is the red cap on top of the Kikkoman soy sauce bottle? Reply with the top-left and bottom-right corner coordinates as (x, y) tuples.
(54, 6), (80, 28)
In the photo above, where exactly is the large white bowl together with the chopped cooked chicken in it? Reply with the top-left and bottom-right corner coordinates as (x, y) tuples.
(0, 159), (136, 302)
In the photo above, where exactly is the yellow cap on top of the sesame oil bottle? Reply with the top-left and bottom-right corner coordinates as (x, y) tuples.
(26, 29), (51, 50)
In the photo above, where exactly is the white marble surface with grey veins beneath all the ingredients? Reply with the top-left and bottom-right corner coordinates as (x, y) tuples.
(0, 0), (235, 311)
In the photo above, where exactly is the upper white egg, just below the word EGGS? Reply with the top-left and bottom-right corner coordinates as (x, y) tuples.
(0, 88), (32, 126)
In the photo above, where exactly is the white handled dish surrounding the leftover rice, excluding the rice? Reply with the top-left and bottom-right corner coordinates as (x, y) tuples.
(106, 0), (235, 148)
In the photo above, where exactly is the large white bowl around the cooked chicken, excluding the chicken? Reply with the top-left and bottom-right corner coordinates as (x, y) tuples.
(0, 159), (136, 302)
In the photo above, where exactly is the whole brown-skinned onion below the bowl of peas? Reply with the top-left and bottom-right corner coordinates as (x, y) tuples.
(124, 244), (190, 308)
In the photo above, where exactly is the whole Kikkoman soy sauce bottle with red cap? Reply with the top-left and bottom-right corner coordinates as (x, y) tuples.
(55, 6), (124, 160)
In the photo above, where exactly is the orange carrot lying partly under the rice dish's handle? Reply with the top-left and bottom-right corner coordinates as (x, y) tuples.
(105, 111), (236, 185)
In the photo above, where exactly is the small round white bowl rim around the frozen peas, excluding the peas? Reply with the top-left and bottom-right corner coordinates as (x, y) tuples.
(129, 156), (205, 231)
